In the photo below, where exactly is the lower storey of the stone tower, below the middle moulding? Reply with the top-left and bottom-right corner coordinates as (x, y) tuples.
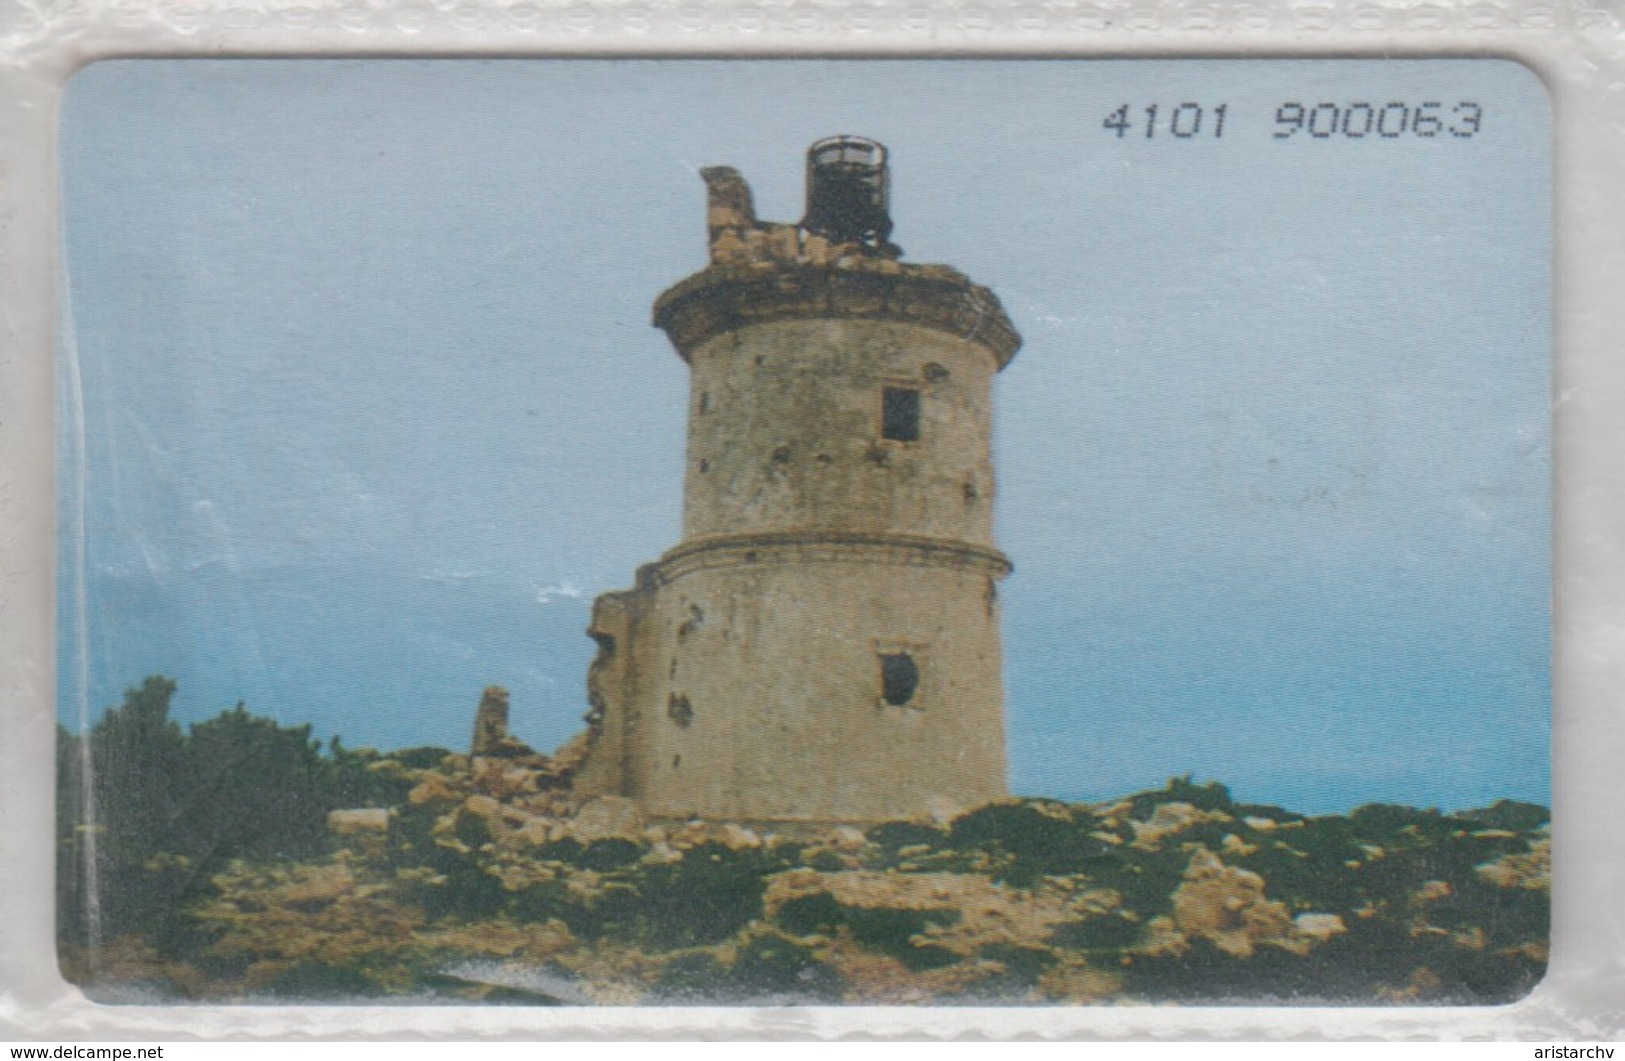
(577, 536), (1008, 822)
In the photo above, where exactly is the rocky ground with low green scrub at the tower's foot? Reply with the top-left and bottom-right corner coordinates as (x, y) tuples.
(63, 746), (1550, 1004)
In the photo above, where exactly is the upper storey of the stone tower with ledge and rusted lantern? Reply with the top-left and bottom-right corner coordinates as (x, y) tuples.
(655, 136), (1021, 545)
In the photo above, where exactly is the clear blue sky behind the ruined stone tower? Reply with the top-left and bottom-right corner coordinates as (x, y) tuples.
(59, 60), (1550, 812)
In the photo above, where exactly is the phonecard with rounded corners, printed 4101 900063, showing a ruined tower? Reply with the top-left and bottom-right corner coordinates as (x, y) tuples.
(57, 58), (1552, 1006)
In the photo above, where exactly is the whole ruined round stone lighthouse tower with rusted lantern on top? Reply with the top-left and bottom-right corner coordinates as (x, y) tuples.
(575, 136), (1021, 822)
